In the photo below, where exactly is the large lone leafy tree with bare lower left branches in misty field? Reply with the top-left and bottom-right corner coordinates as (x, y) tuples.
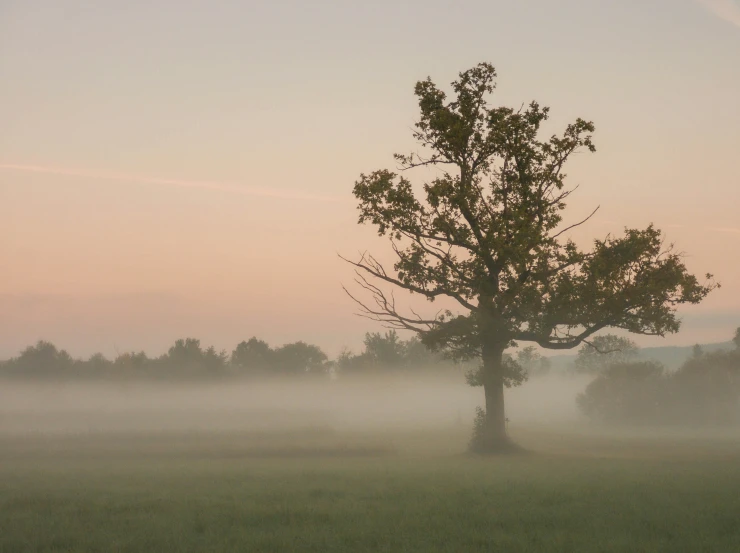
(346, 63), (716, 452)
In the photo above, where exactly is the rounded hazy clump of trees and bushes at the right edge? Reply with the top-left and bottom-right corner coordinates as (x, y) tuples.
(577, 328), (740, 426)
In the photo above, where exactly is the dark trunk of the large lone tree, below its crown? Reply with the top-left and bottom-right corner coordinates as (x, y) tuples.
(471, 344), (512, 453)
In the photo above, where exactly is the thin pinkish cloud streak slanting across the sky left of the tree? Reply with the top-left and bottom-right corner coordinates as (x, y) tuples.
(0, 163), (341, 202)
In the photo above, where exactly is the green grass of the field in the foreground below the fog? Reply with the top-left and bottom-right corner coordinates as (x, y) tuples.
(0, 429), (740, 553)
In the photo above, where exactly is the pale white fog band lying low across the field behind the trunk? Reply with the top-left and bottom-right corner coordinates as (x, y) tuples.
(0, 375), (590, 434)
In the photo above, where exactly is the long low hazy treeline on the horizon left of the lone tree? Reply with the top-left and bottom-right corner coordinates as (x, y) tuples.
(0, 331), (468, 379)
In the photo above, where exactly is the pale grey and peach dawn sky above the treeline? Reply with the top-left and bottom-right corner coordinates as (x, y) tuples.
(0, 0), (740, 357)
